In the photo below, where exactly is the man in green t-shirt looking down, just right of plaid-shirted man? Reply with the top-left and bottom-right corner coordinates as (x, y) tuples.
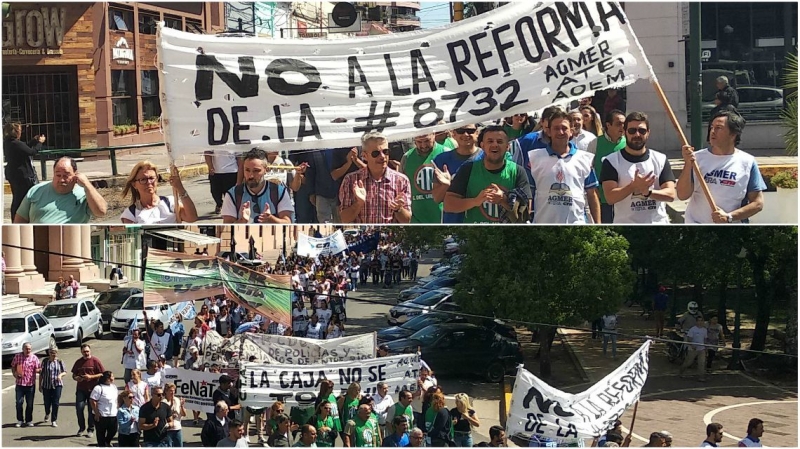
(400, 133), (448, 223)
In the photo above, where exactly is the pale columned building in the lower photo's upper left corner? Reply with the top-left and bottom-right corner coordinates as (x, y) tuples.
(2, 225), (141, 293)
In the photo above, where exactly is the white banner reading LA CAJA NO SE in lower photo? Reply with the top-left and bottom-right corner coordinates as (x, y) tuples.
(239, 354), (419, 408)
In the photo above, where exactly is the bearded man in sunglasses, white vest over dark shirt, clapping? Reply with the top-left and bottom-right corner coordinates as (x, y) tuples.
(600, 112), (675, 224)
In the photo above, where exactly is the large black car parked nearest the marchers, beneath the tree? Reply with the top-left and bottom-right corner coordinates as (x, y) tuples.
(386, 323), (524, 382)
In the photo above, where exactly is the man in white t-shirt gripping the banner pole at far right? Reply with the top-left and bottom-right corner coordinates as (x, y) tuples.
(677, 111), (767, 223)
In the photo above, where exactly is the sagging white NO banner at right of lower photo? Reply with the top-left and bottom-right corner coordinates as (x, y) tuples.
(506, 340), (652, 440)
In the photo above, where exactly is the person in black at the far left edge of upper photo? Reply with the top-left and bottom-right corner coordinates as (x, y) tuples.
(3, 123), (39, 220)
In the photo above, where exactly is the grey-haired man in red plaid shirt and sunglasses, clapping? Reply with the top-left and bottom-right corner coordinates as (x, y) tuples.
(339, 132), (411, 224)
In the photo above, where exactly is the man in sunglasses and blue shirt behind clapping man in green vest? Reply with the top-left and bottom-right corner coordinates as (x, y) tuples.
(433, 125), (483, 223)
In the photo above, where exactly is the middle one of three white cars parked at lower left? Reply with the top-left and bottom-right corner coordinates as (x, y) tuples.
(42, 298), (103, 346)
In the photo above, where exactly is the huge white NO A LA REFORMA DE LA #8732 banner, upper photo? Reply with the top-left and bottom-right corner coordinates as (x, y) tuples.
(158, 1), (655, 157)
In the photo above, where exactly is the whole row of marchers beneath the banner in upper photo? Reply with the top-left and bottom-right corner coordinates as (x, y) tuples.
(4, 83), (766, 224)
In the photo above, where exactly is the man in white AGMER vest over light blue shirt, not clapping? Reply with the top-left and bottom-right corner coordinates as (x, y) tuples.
(526, 109), (600, 220)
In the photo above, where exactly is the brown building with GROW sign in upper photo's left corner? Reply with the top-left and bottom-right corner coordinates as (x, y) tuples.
(2, 2), (224, 149)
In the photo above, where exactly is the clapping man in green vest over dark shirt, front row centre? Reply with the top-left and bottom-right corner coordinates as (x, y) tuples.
(444, 126), (531, 223)
